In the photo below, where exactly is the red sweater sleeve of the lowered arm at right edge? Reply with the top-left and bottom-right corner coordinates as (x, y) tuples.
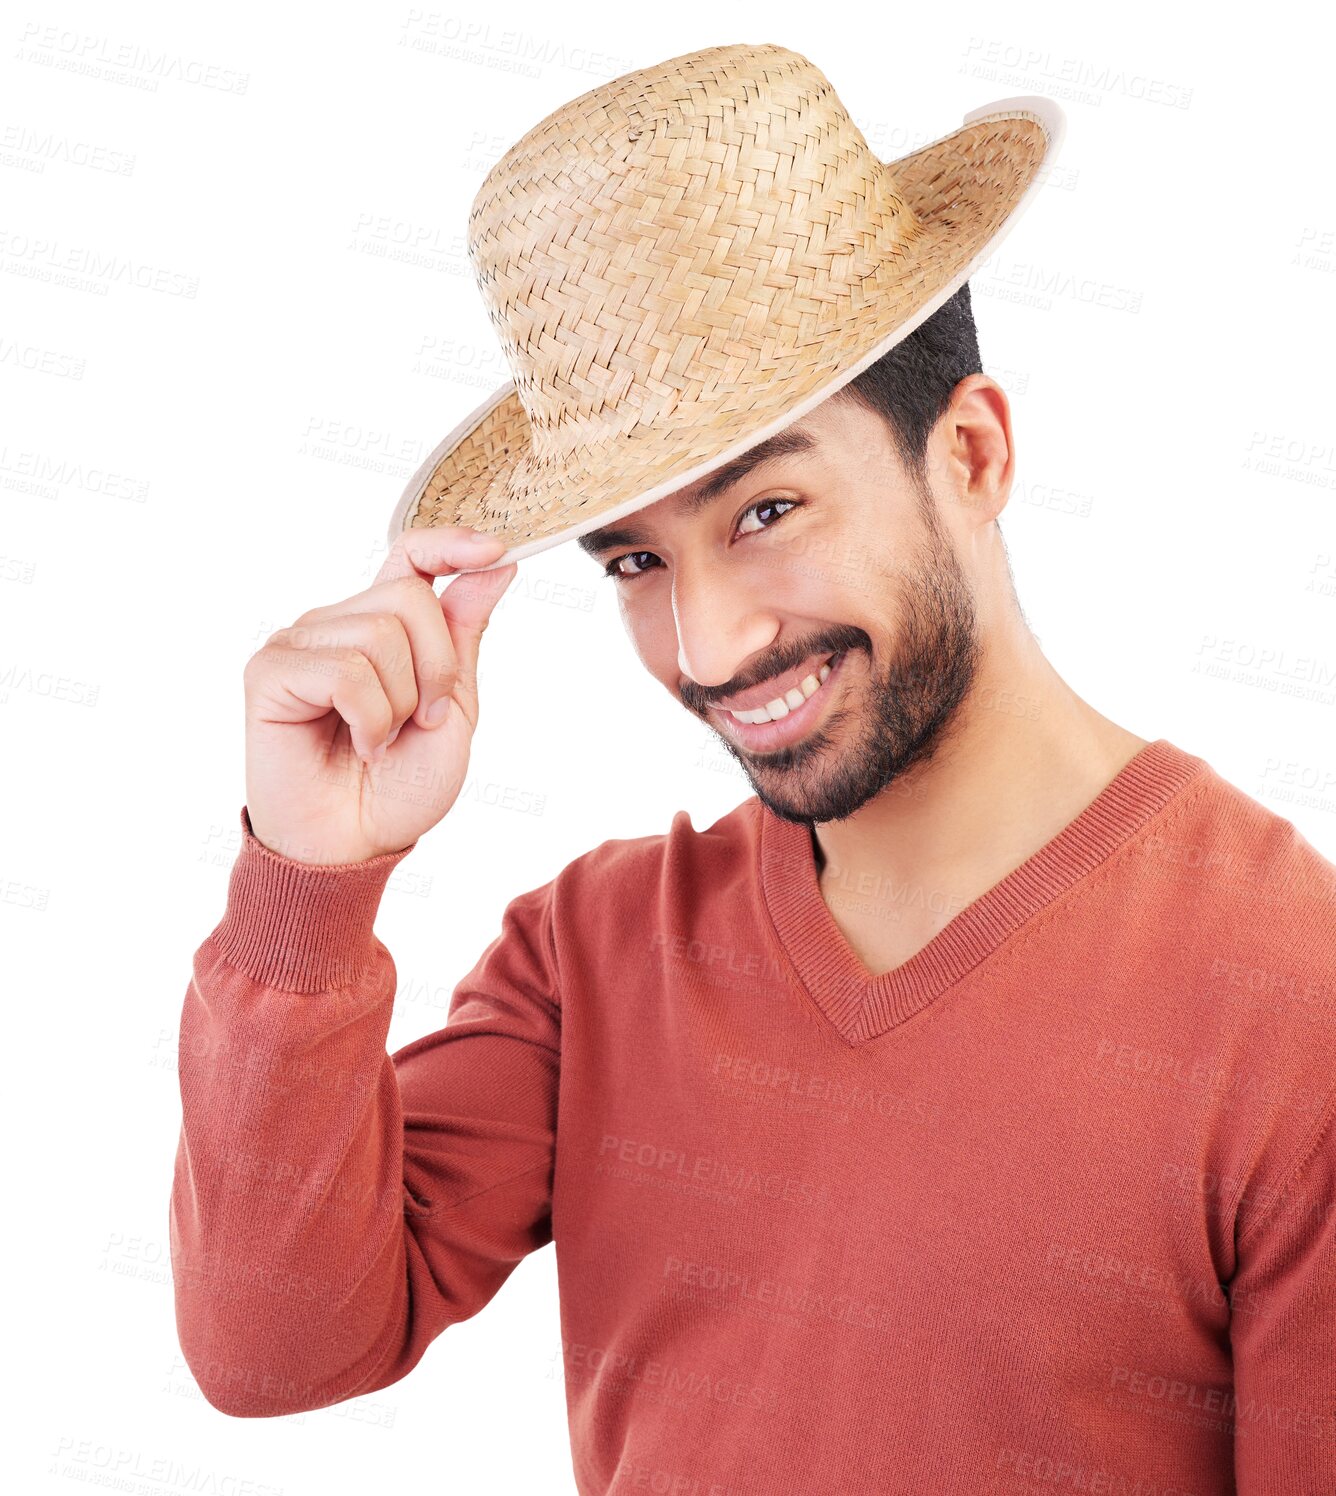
(1230, 1103), (1336, 1496)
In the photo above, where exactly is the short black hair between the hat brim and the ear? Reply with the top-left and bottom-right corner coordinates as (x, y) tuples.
(832, 281), (983, 492)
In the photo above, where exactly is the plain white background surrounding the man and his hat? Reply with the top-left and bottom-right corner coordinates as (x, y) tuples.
(10, 0), (1336, 1496)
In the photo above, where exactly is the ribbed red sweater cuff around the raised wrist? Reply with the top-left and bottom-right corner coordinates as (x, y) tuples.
(212, 805), (417, 992)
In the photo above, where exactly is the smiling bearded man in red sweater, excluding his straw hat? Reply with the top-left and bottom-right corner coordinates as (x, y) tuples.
(171, 40), (1336, 1496)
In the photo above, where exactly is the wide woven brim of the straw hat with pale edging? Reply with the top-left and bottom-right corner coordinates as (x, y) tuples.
(387, 94), (1065, 570)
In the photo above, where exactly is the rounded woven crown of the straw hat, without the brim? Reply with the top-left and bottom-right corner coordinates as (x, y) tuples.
(468, 43), (919, 465)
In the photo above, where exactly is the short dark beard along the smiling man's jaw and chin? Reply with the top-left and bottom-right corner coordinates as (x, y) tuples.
(703, 509), (981, 826)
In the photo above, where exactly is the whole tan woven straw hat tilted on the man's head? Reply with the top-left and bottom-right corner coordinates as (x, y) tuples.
(389, 43), (1065, 565)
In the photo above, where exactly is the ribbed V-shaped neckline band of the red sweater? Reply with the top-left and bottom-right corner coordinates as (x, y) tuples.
(753, 738), (1206, 1044)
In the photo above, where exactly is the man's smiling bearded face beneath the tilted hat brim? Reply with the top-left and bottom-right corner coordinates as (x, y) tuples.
(579, 399), (980, 823)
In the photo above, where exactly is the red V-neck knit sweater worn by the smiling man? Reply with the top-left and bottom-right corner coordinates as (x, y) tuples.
(171, 739), (1336, 1496)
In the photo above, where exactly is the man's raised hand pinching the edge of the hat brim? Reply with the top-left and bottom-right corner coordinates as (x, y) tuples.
(244, 525), (518, 863)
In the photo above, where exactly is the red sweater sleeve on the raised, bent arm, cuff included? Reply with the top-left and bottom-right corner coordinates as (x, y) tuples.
(169, 806), (560, 1417)
